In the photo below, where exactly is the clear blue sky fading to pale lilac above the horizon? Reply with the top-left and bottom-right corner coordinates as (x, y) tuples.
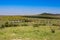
(0, 0), (60, 15)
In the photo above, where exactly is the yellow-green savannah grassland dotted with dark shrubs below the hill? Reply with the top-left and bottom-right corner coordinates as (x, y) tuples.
(0, 16), (60, 40)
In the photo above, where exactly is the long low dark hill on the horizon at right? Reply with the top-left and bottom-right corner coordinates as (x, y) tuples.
(25, 13), (60, 19)
